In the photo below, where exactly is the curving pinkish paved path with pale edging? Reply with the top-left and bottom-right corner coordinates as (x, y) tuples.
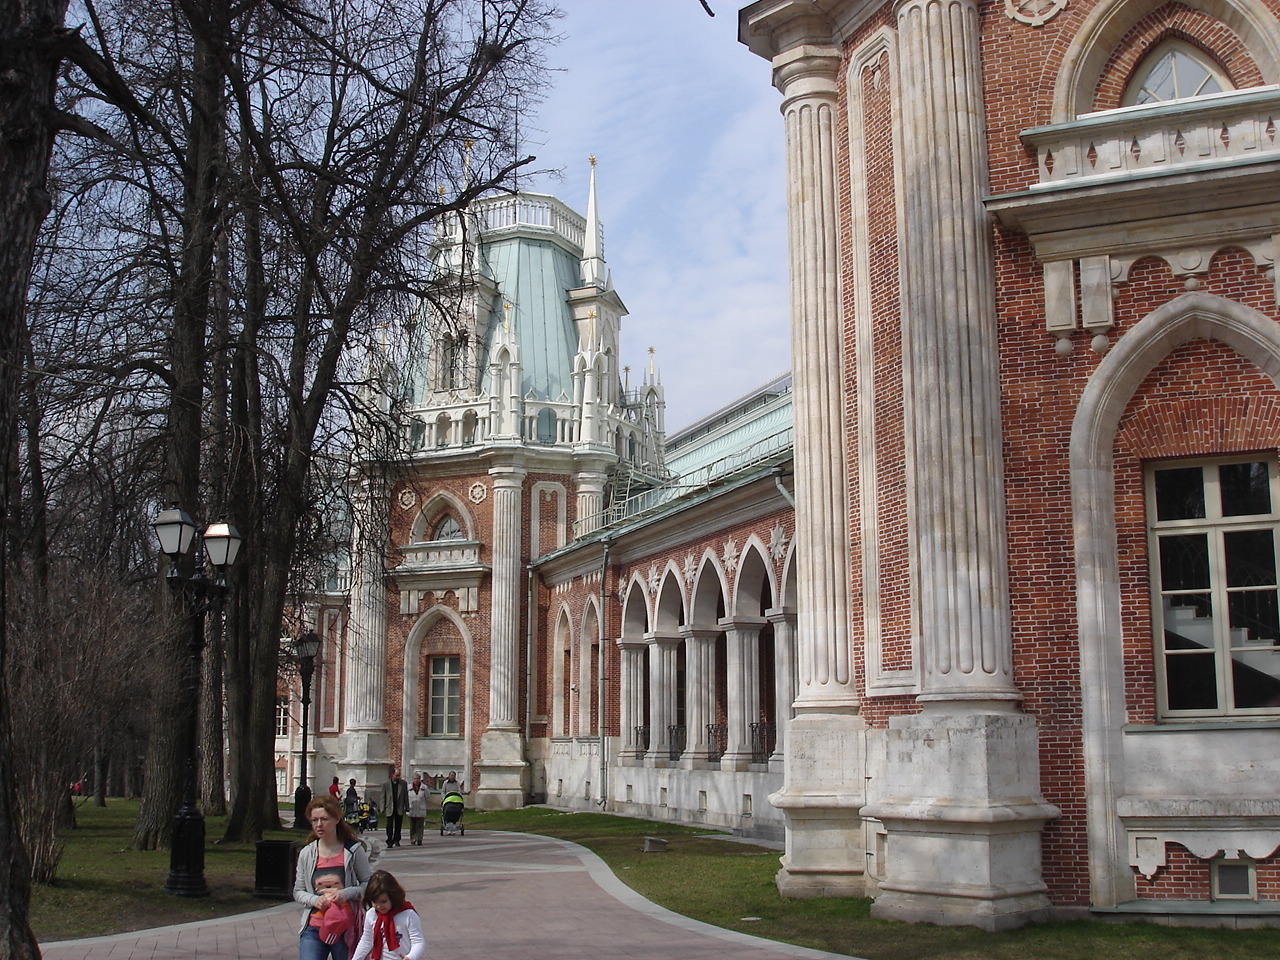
(41, 831), (865, 960)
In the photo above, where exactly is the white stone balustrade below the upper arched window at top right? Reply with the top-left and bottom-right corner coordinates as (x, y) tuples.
(1021, 86), (1280, 189)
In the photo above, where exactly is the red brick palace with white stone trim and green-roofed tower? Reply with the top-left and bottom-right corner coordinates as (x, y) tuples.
(275, 0), (1280, 928)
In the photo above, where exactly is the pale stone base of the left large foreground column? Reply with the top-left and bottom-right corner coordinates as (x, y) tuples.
(769, 708), (867, 899)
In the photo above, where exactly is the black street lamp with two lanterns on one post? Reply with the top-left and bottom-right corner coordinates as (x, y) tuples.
(151, 503), (241, 897)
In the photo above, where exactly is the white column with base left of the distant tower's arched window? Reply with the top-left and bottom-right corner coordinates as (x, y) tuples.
(342, 480), (389, 783)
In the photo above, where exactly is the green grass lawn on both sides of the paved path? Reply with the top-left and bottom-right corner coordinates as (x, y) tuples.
(32, 800), (1280, 960)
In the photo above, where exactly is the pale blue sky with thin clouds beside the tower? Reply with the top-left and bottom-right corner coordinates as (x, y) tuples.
(520, 0), (791, 434)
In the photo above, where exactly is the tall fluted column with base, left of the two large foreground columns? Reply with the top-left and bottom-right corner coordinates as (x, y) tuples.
(762, 32), (865, 896)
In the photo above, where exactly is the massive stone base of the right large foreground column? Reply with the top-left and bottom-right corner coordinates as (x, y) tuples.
(863, 709), (1060, 931)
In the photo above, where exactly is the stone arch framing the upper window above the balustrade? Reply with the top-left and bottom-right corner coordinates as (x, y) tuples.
(1050, 0), (1280, 123)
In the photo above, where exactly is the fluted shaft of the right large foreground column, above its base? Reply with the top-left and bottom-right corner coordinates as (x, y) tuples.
(897, 0), (1018, 700)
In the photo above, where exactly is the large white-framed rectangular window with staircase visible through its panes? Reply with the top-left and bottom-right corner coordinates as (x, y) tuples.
(1147, 456), (1280, 717)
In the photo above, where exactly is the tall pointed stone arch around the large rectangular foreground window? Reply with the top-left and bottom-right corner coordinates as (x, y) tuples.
(1070, 293), (1280, 906)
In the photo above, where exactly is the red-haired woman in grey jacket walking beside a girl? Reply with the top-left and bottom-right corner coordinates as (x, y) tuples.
(293, 796), (372, 960)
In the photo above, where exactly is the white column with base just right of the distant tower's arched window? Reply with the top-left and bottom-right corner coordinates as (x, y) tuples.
(476, 465), (527, 809)
